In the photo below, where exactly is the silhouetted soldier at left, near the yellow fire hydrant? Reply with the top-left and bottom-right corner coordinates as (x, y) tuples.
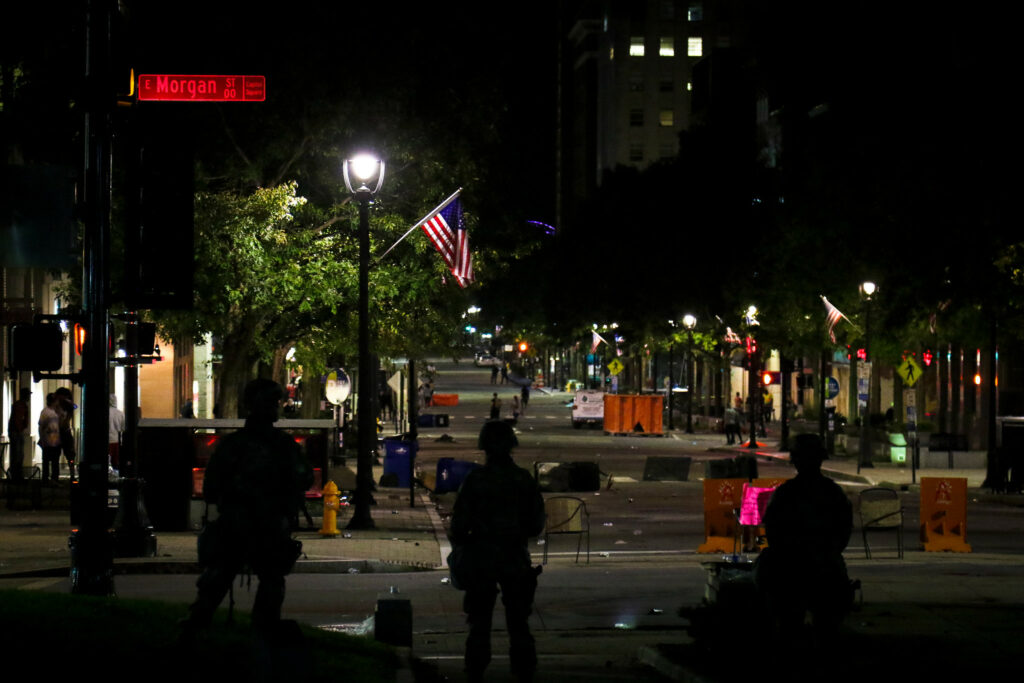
(184, 380), (313, 638)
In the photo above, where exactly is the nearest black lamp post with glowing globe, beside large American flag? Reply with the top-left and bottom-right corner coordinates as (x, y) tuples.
(342, 154), (384, 529)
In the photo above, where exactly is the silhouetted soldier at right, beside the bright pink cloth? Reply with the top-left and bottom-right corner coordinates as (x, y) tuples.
(757, 434), (853, 643)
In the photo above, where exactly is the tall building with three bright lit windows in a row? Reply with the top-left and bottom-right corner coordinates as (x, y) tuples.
(558, 0), (725, 232)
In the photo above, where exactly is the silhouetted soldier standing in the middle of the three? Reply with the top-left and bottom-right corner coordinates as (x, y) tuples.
(452, 422), (545, 681)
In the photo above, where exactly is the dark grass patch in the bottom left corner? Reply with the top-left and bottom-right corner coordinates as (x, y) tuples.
(0, 591), (399, 683)
